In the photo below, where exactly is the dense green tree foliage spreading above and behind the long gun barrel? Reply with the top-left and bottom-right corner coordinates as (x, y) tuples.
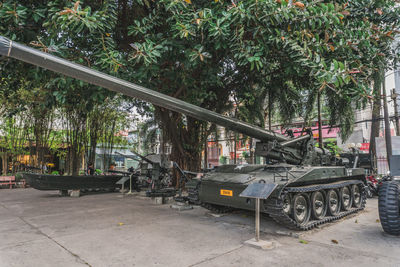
(0, 0), (399, 174)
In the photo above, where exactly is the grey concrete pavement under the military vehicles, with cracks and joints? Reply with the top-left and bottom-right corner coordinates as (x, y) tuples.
(0, 189), (400, 267)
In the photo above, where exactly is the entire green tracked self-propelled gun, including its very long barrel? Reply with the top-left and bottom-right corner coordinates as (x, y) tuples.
(0, 36), (366, 230)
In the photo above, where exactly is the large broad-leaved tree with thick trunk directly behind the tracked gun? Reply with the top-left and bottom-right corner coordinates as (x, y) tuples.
(118, 0), (398, 172)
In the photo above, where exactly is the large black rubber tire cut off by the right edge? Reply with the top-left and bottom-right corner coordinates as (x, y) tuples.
(379, 181), (400, 235)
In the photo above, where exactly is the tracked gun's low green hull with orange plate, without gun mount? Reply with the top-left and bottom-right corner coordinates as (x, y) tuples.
(199, 164), (365, 230)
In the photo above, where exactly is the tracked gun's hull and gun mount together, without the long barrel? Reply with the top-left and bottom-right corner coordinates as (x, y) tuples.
(187, 133), (366, 230)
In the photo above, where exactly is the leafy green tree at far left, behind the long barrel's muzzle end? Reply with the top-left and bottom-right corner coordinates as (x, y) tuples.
(0, 0), (121, 174)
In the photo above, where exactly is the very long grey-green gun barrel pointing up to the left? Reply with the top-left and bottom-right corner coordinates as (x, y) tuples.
(0, 36), (290, 142)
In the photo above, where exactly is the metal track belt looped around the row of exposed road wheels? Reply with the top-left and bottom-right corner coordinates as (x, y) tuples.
(265, 180), (366, 231)
